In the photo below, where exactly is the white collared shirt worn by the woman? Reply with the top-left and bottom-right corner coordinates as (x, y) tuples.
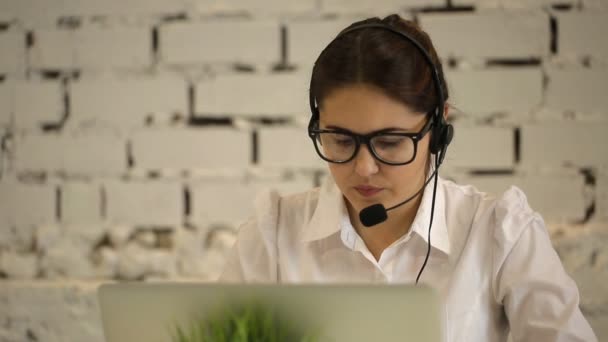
(220, 177), (597, 342)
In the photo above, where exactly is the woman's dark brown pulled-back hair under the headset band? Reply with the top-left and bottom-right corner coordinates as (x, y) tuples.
(310, 14), (448, 113)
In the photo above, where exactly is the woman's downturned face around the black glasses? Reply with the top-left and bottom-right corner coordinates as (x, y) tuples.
(320, 85), (430, 218)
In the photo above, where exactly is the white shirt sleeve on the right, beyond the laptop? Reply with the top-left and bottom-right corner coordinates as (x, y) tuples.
(495, 188), (597, 342)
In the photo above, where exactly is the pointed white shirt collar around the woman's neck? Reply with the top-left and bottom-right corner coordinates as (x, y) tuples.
(301, 172), (450, 254)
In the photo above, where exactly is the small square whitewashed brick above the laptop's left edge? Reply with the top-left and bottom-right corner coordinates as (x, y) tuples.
(61, 182), (101, 224)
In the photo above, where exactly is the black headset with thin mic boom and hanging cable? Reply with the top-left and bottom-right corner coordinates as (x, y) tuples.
(308, 23), (454, 284)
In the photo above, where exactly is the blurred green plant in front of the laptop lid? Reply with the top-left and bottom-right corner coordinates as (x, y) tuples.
(172, 302), (320, 342)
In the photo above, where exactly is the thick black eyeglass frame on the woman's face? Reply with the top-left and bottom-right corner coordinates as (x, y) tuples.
(308, 115), (433, 166)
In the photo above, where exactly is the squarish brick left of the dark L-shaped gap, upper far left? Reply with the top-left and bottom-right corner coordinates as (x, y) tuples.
(15, 81), (65, 131)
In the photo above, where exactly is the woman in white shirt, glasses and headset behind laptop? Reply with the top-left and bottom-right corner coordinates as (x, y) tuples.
(220, 15), (596, 341)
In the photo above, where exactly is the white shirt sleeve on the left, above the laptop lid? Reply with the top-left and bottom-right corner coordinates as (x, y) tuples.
(218, 192), (280, 283)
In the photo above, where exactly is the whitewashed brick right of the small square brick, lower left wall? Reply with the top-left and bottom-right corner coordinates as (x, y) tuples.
(104, 181), (184, 226)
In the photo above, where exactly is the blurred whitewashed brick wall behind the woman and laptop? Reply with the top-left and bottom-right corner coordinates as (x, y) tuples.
(0, 0), (608, 341)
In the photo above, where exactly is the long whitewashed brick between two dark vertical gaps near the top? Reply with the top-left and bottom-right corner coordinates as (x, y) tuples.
(159, 19), (280, 65)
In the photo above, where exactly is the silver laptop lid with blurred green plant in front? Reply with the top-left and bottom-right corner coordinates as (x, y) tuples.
(98, 282), (442, 342)
